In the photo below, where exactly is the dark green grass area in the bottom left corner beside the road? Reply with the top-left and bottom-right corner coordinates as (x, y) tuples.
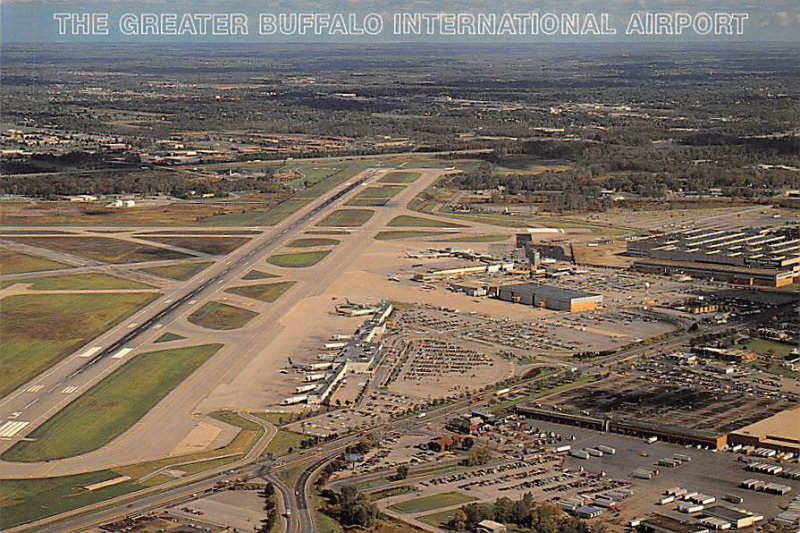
(0, 470), (141, 530)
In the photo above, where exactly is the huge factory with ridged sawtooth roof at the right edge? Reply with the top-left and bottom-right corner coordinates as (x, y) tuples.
(627, 228), (800, 287)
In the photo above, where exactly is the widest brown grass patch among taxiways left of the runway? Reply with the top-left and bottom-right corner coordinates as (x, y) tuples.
(9, 237), (189, 264)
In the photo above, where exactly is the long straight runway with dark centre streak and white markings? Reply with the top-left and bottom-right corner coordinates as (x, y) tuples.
(0, 169), (377, 452)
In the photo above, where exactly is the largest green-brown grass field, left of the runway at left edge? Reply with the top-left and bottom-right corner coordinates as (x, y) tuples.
(0, 293), (158, 396)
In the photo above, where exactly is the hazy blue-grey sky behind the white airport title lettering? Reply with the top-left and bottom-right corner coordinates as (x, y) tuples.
(0, 0), (800, 44)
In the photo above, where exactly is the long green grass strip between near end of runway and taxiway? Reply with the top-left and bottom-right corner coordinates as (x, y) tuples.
(2, 344), (222, 462)
